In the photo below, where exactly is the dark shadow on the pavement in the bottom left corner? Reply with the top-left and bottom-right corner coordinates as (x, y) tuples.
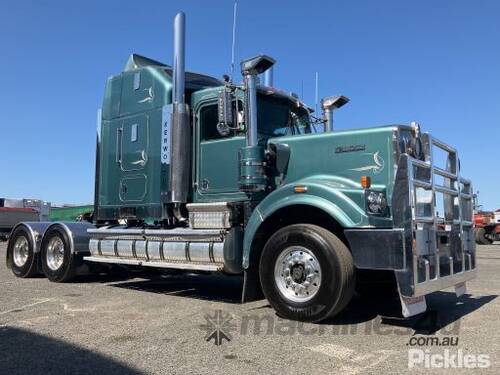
(0, 327), (141, 375)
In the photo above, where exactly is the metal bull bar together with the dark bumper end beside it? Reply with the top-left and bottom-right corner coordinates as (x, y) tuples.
(345, 134), (477, 298)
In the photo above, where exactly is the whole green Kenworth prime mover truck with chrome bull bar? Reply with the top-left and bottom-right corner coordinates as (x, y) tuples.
(7, 13), (476, 322)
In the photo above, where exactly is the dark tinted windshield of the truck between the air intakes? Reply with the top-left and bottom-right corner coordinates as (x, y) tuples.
(257, 95), (311, 139)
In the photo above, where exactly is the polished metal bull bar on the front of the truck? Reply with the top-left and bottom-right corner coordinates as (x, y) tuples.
(393, 133), (477, 297)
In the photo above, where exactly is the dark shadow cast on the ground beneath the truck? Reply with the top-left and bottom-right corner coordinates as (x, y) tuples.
(84, 274), (498, 334)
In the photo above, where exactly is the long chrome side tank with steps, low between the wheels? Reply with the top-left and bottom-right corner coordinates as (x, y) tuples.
(85, 227), (243, 273)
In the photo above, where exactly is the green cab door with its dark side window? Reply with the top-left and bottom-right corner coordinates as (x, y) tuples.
(195, 102), (246, 201)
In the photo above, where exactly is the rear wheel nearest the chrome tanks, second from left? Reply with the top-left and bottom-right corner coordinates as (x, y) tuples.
(40, 227), (81, 283)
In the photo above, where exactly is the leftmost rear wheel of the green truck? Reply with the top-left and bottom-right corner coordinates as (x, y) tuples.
(7, 226), (38, 278)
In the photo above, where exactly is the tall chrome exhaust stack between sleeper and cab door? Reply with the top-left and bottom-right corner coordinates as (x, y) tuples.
(169, 12), (191, 222)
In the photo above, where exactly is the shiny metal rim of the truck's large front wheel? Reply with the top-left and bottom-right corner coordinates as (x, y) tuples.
(274, 246), (321, 302)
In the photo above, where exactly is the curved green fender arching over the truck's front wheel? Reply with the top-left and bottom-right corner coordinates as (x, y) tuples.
(243, 176), (370, 269)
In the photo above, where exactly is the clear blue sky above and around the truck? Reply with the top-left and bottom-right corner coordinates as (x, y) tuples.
(0, 0), (500, 209)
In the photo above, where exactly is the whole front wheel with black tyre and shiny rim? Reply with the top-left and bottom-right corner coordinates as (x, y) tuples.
(259, 224), (355, 322)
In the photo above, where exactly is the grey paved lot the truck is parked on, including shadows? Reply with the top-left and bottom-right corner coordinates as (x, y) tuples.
(0, 244), (500, 375)
